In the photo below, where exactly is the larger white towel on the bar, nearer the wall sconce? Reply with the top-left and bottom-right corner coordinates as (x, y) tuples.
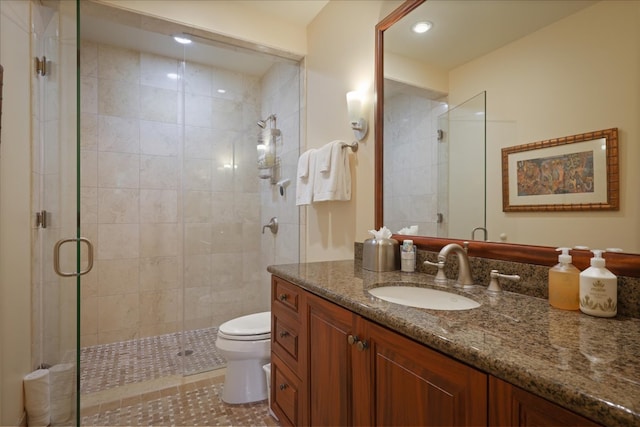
(313, 141), (351, 202)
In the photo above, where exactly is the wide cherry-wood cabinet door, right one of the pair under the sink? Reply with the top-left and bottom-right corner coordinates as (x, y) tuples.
(367, 322), (487, 426)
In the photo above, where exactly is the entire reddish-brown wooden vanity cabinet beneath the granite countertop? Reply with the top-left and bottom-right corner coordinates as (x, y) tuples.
(271, 276), (597, 426)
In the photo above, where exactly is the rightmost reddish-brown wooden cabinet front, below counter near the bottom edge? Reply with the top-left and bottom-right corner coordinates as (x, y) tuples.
(489, 376), (598, 427)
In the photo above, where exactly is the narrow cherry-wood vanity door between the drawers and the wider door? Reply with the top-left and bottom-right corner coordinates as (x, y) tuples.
(307, 294), (354, 426)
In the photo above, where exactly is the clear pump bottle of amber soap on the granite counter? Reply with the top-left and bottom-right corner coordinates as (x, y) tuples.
(549, 248), (580, 310)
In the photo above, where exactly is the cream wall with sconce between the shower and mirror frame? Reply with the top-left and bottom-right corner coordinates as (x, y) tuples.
(307, 1), (385, 261)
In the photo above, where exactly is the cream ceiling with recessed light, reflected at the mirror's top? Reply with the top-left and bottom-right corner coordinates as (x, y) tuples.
(384, 0), (597, 70)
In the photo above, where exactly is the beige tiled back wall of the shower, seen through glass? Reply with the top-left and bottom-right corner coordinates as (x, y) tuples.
(81, 42), (260, 346)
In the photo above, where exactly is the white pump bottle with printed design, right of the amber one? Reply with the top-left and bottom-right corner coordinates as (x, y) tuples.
(580, 249), (618, 317)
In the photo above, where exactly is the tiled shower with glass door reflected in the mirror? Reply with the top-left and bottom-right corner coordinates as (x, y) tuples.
(383, 87), (485, 239)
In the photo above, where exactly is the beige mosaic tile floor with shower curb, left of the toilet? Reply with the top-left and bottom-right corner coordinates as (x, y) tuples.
(80, 328), (279, 426)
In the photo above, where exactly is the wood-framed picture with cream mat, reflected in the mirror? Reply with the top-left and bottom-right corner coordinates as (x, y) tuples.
(502, 128), (620, 212)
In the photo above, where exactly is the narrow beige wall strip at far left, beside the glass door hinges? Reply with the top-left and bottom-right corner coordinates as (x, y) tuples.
(0, 0), (31, 425)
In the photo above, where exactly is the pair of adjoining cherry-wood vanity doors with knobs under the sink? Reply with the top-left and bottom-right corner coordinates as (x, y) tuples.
(307, 295), (487, 426)
